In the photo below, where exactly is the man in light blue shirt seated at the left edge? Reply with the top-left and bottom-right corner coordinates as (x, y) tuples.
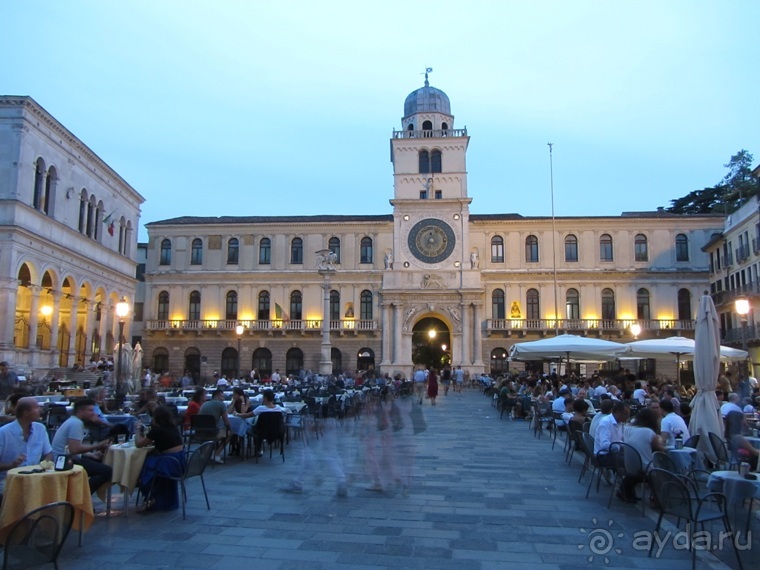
(0, 398), (53, 487)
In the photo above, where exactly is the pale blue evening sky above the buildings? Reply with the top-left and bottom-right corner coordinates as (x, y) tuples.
(0, 0), (760, 240)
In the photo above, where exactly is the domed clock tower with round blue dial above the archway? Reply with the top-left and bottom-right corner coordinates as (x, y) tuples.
(381, 72), (484, 377)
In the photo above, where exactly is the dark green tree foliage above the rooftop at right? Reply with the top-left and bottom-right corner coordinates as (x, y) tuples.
(666, 149), (760, 214)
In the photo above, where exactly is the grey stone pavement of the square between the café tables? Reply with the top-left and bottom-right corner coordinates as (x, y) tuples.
(60, 390), (760, 570)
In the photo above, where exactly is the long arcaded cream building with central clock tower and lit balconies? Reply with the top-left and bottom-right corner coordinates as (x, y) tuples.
(142, 78), (723, 378)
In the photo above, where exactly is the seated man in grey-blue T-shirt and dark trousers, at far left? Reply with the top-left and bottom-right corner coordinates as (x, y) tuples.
(53, 398), (112, 493)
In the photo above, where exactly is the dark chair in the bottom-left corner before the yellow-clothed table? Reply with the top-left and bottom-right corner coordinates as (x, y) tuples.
(3, 496), (74, 570)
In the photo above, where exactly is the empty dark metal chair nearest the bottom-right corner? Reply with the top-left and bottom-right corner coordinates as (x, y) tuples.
(649, 469), (743, 570)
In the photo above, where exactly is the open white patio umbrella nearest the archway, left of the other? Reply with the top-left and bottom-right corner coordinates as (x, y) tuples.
(509, 334), (628, 362)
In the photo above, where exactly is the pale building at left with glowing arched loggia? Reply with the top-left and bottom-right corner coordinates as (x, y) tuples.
(0, 96), (144, 373)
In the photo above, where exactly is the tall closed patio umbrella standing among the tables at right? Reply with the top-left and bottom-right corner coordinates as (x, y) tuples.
(689, 295), (724, 461)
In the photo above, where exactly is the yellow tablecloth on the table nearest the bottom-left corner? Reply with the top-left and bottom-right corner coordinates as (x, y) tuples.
(0, 465), (94, 542)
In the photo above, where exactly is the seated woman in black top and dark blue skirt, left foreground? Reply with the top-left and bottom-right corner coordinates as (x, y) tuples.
(135, 406), (185, 512)
